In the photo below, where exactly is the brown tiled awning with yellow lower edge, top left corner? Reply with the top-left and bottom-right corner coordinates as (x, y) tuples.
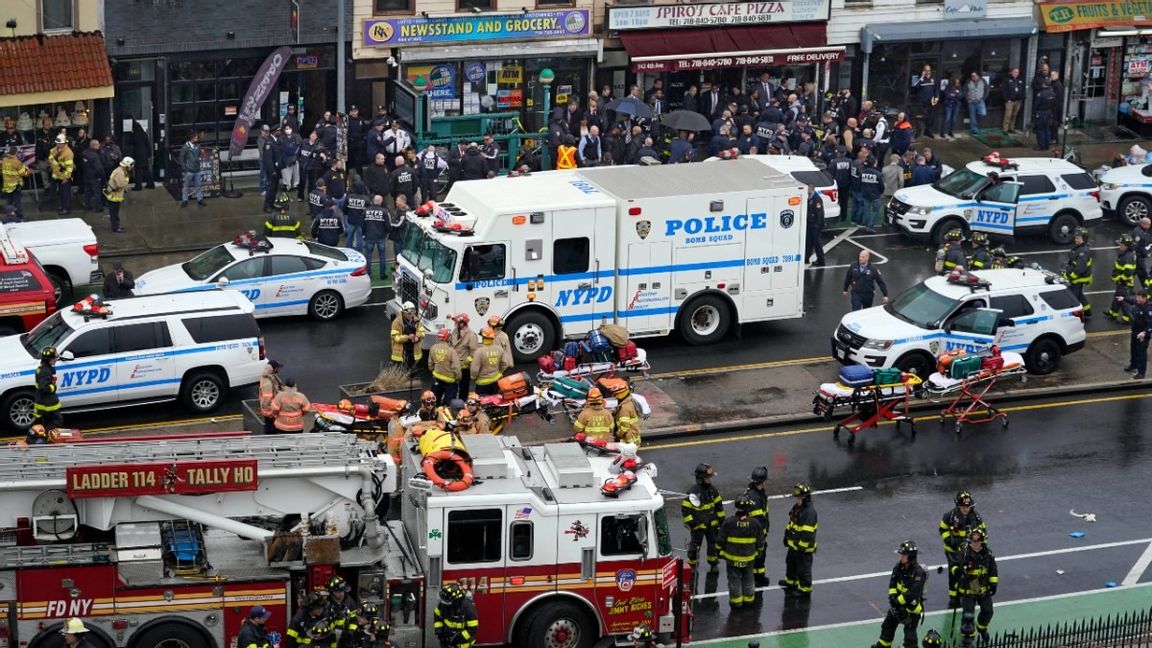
(0, 32), (113, 107)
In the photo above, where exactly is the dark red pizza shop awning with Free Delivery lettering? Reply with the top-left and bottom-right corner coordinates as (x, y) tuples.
(620, 22), (844, 71)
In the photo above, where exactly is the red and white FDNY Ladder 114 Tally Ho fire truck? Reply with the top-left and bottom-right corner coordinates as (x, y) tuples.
(0, 434), (689, 648)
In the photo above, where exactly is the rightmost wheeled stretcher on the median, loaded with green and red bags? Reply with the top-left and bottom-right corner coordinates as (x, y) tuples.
(925, 346), (1028, 435)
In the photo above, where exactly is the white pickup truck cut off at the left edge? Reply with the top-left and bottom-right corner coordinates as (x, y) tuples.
(0, 218), (104, 306)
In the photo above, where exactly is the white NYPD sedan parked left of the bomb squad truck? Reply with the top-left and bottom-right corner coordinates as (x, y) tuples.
(135, 238), (372, 321)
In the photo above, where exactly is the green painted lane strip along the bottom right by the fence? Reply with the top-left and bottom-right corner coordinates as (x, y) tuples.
(691, 583), (1152, 648)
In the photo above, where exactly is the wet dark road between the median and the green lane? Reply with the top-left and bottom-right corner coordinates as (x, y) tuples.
(644, 394), (1152, 645)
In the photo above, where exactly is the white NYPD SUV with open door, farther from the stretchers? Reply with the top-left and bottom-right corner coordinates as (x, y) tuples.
(886, 156), (1102, 246)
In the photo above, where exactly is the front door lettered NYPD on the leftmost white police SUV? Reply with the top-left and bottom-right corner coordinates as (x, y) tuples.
(56, 321), (119, 407)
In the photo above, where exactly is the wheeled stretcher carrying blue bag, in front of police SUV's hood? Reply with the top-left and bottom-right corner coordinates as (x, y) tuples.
(812, 374), (922, 445)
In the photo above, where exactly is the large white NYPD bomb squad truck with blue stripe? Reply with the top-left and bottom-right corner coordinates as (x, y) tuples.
(388, 159), (806, 361)
